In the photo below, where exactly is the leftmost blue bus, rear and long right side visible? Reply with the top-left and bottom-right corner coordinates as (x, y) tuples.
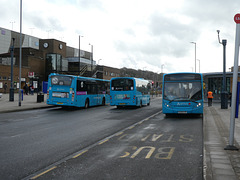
(47, 73), (110, 108)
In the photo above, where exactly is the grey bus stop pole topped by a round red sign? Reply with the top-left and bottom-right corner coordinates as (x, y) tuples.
(224, 14), (240, 150)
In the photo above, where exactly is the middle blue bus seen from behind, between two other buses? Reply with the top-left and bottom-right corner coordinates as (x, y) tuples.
(110, 77), (151, 108)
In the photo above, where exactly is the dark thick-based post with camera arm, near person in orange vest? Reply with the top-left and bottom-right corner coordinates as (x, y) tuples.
(217, 30), (228, 109)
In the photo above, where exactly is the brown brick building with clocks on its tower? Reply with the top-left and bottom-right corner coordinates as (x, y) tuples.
(0, 28), (96, 92)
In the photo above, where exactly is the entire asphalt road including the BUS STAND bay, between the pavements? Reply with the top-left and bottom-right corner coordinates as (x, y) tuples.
(0, 99), (202, 179)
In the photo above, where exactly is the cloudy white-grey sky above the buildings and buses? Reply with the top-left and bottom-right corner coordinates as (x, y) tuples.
(0, 0), (240, 73)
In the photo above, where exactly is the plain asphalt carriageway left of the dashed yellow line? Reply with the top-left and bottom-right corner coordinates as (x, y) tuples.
(0, 98), (161, 179)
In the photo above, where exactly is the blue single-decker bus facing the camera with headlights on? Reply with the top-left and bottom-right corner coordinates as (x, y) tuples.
(162, 73), (203, 116)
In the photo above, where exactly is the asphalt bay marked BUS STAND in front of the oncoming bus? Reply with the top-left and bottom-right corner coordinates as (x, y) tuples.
(35, 113), (203, 180)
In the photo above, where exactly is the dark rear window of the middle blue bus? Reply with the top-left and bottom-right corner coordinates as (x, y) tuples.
(111, 79), (134, 91)
